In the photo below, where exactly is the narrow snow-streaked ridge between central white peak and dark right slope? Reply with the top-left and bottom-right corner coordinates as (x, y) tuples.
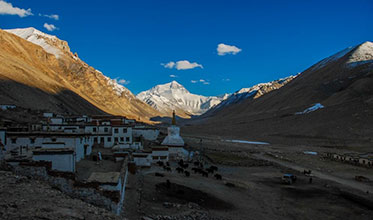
(203, 76), (297, 117)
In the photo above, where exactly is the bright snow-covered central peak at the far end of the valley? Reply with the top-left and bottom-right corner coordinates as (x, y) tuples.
(136, 81), (227, 117)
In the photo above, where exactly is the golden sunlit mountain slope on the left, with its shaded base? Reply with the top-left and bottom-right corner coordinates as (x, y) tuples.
(0, 28), (159, 119)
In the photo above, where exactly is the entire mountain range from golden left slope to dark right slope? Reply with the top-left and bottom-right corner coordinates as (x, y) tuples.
(0, 28), (373, 145)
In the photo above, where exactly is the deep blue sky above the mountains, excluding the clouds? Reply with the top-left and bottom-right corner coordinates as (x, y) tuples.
(0, 0), (373, 95)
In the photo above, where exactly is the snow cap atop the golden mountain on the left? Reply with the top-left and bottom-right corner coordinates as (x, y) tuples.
(5, 27), (63, 58)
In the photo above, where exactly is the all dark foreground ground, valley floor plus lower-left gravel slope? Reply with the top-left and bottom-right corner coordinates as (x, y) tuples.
(0, 136), (373, 220)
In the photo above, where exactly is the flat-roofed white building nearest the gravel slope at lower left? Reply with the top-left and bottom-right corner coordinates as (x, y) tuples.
(32, 148), (76, 173)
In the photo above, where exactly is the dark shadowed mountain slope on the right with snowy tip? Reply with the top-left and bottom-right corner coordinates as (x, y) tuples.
(184, 42), (373, 146)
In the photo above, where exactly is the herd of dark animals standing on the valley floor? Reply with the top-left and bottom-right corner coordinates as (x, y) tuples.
(155, 159), (222, 180)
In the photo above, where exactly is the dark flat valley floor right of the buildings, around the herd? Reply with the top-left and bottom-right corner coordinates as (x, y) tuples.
(124, 136), (373, 219)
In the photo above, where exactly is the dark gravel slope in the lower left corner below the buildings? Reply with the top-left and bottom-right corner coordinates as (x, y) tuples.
(0, 171), (119, 219)
